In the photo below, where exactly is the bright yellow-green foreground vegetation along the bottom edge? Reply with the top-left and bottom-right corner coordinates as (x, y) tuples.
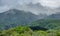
(0, 26), (60, 36)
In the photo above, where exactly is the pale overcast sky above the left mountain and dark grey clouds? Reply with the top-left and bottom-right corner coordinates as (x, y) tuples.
(0, 0), (60, 12)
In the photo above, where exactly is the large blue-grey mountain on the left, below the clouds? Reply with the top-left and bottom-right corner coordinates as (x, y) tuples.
(0, 9), (38, 29)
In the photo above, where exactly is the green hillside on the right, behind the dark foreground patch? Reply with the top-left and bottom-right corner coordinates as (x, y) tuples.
(31, 19), (60, 29)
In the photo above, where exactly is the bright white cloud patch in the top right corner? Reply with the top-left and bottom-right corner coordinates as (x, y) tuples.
(39, 0), (60, 8)
